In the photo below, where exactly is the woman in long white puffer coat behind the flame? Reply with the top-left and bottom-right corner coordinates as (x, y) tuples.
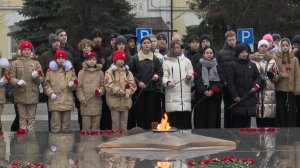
(163, 41), (194, 129)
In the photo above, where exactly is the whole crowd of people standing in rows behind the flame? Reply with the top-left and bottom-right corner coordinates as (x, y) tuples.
(0, 29), (300, 134)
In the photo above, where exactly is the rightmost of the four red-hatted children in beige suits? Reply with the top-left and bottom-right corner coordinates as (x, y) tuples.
(105, 50), (136, 130)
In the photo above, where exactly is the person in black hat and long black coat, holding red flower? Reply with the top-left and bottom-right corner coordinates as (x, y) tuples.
(226, 44), (261, 128)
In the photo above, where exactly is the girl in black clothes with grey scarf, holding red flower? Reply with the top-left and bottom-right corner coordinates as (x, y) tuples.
(193, 47), (224, 128)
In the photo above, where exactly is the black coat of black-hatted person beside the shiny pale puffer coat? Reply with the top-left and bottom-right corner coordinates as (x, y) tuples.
(226, 58), (261, 116)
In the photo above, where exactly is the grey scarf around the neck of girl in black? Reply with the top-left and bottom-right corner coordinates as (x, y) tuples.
(200, 58), (220, 86)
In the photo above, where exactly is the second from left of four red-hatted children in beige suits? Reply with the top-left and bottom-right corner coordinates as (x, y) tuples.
(44, 49), (78, 134)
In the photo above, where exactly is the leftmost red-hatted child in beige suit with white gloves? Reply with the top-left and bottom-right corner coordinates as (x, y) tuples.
(10, 41), (44, 132)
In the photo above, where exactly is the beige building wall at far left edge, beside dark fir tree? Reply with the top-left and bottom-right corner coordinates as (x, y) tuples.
(0, 0), (23, 58)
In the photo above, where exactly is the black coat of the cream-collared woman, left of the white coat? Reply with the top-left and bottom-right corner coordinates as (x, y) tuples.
(128, 54), (163, 91)
